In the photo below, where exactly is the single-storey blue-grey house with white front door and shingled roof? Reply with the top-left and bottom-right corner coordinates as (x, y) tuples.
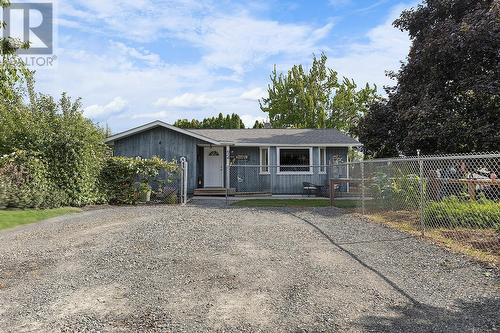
(106, 121), (361, 194)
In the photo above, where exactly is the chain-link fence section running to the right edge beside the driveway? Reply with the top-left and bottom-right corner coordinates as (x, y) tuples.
(330, 153), (500, 255)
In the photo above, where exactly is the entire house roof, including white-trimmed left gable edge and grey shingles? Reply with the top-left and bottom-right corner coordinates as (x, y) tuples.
(106, 120), (361, 147)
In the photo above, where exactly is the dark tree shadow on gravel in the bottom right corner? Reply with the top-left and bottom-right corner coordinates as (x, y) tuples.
(358, 298), (500, 333)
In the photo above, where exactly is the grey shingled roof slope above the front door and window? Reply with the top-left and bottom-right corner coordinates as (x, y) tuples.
(189, 128), (361, 146)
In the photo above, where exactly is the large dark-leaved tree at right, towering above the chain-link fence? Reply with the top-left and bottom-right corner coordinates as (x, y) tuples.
(360, 0), (500, 156)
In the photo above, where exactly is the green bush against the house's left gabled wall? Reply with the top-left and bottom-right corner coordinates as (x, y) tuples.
(100, 157), (179, 204)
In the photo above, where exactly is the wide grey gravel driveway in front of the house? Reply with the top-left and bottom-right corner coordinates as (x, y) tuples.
(0, 200), (500, 332)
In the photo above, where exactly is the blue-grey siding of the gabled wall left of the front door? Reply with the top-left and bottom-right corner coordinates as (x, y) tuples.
(113, 127), (206, 192)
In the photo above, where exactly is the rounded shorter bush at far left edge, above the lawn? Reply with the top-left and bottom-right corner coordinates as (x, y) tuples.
(0, 151), (66, 208)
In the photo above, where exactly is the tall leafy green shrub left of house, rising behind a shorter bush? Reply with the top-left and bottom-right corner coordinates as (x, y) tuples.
(0, 94), (109, 206)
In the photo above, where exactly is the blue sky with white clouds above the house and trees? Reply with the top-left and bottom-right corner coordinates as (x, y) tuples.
(31, 0), (415, 133)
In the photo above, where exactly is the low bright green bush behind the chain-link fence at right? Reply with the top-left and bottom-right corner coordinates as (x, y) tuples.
(424, 197), (500, 231)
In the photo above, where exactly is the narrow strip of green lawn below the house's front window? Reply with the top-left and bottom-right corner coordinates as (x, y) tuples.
(232, 199), (356, 208)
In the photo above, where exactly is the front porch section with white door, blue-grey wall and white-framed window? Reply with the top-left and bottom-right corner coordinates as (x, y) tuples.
(193, 145), (349, 197)
